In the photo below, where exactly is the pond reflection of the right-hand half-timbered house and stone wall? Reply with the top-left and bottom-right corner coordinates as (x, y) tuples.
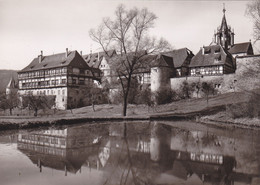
(171, 125), (260, 184)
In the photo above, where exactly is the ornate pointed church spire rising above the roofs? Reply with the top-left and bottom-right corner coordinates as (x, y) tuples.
(214, 7), (235, 50)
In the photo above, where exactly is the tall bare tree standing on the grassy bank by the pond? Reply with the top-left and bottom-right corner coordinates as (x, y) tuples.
(89, 5), (170, 116)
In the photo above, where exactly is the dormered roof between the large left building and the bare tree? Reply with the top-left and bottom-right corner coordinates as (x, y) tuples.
(82, 50), (116, 68)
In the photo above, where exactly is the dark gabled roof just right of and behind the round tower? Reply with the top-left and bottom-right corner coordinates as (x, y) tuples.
(162, 48), (194, 68)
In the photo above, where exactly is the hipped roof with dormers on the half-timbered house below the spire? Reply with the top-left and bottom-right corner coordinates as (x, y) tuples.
(189, 45), (232, 67)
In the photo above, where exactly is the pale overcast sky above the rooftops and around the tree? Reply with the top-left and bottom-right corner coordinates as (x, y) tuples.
(0, 0), (253, 70)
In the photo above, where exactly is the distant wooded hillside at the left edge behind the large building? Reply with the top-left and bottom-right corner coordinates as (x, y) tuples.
(0, 70), (17, 93)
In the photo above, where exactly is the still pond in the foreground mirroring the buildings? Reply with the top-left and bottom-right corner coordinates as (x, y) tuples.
(0, 121), (260, 185)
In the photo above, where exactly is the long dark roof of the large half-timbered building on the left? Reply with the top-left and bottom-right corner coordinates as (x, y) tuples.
(19, 51), (89, 72)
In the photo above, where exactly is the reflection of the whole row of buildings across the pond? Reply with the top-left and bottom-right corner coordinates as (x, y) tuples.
(15, 123), (260, 185)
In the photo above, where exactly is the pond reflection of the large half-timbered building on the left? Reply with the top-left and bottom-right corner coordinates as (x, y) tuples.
(17, 126), (107, 175)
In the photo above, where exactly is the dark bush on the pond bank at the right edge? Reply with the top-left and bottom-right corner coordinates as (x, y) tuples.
(226, 94), (260, 119)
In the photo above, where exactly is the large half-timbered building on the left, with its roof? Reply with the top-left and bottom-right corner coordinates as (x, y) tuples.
(18, 49), (93, 109)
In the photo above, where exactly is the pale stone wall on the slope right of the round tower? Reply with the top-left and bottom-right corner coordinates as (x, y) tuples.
(171, 55), (260, 93)
